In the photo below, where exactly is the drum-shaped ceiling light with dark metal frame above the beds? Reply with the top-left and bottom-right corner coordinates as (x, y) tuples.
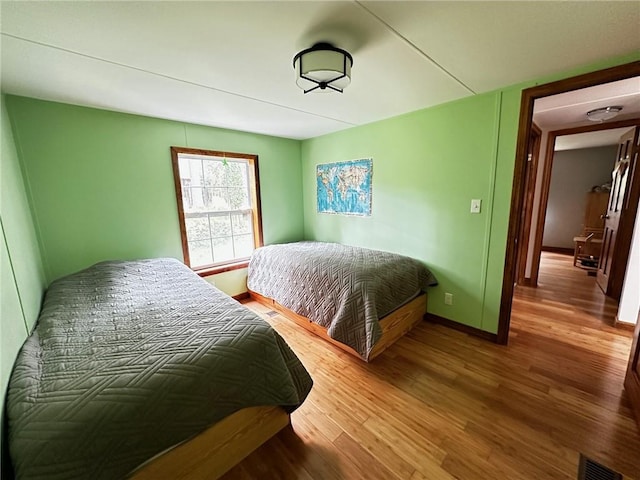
(293, 42), (353, 93)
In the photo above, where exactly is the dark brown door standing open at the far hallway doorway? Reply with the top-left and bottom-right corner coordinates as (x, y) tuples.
(596, 127), (637, 300)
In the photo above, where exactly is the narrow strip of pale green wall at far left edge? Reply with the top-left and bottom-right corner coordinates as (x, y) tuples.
(0, 96), (45, 442)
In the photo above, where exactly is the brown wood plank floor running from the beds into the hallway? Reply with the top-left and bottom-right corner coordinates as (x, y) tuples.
(224, 254), (640, 480)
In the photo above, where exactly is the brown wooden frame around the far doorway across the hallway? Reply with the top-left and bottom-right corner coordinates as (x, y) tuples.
(529, 118), (640, 287)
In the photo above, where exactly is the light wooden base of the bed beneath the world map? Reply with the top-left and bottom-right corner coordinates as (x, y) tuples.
(249, 290), (427, 362)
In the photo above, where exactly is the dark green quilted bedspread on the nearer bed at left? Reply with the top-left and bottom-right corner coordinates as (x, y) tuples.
(7, 259), (312, 479)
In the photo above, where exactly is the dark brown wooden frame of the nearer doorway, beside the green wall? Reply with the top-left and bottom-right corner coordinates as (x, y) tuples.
(497, 61), (640, 344)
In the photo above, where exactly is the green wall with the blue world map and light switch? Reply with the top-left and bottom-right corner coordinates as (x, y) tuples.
(302, 53), (638, 333)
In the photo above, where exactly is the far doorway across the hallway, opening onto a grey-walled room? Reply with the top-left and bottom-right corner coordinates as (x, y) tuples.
(524, 127), (633, 335)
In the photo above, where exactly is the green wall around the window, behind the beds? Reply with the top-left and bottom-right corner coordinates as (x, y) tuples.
(7, 96), (303, 295)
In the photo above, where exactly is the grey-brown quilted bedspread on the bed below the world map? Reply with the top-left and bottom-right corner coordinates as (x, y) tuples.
(247, 242), (437, 360)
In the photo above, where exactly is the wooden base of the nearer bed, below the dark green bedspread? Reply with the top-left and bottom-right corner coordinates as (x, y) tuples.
(129, 406), (290, 480)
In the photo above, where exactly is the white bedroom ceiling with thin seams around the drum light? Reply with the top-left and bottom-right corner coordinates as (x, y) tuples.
(0, 1), (640, 139)
